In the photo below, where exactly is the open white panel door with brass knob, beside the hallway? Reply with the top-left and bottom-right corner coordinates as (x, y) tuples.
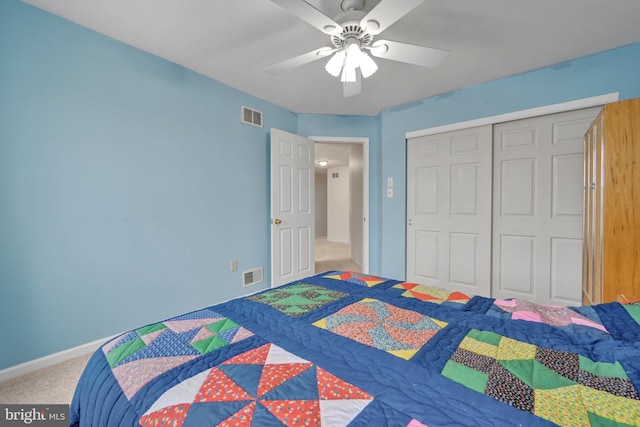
(271, 129), (315, 287)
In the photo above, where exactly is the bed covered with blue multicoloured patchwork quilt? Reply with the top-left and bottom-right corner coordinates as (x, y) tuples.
(70, 271), (640, 427)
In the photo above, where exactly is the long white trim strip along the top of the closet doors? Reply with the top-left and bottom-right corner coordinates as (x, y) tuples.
(404, 92), (620, 139)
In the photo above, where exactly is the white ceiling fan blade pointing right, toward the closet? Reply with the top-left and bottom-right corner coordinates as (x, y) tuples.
(370, 40), (451, 68)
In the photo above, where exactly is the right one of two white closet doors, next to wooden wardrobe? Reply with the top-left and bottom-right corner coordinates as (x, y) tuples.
(492, 107), (600, 305)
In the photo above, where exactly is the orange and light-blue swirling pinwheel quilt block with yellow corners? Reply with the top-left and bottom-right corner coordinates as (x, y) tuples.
(313, 298), (447, 360)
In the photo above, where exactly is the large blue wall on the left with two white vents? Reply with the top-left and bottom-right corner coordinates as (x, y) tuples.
(0, 0), (297, 369)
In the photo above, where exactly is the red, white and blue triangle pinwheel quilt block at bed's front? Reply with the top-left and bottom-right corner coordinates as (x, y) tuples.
(139, 343), (374, 427)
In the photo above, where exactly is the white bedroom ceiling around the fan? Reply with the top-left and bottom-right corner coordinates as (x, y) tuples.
(24, 0), (640, 115)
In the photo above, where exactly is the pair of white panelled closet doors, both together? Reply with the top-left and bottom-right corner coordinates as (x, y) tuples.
(407, 107), (601, 305)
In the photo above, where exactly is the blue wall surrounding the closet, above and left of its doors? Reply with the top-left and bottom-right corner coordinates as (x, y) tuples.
(378, 43), (640, 279)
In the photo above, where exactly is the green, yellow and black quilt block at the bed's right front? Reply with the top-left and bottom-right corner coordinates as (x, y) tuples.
(442, 330), (640, 426)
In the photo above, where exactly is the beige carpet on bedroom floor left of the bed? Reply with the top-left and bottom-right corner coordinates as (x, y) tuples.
(0, 354), (91, 405)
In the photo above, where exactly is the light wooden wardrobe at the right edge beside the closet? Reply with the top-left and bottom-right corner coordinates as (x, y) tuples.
(582, 98), (640, 305)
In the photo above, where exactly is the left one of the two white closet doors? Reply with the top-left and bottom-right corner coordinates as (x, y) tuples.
(407, 125), (492, 296)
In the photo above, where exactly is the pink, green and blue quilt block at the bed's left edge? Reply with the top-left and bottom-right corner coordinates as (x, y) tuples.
(102, 309), (253, 399)
